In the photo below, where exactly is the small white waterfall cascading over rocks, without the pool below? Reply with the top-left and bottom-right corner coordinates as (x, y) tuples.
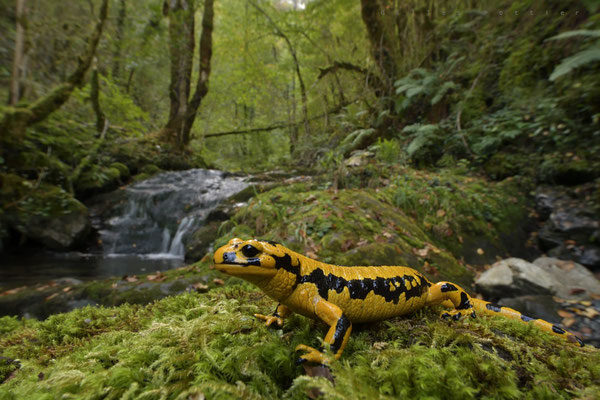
(99, 169), (247, 259)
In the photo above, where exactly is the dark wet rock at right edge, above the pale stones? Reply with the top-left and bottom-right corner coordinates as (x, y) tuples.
(535, 182), (600, 269)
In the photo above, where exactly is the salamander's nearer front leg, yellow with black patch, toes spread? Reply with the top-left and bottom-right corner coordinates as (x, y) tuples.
(296, 297), (352, 364)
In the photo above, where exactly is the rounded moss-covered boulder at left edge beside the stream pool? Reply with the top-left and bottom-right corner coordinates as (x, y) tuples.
(0, 174), (90, 249)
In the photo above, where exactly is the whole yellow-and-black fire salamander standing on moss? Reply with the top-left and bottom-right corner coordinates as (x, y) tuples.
(214, 239), (583, 364)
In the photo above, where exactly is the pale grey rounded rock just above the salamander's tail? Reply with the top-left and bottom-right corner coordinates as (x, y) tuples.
(475, 258), (560, 299)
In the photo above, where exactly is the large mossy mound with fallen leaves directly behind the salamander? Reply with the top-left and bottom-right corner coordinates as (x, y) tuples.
(215, 184), (472, 286)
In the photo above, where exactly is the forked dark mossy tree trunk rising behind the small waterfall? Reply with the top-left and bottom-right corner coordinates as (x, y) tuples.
(161, 0), (214, 149)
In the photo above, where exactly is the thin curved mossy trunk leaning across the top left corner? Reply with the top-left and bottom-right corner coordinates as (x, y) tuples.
(0, 0), (108, 140)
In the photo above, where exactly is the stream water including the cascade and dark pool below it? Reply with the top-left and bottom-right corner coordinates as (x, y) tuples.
(0, 169), (247, 289)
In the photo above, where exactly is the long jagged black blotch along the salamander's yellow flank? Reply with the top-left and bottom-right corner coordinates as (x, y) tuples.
(299, 268), (430, 304)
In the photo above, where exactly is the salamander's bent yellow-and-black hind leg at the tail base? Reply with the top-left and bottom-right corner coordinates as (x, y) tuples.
(426, 282), (475, 320)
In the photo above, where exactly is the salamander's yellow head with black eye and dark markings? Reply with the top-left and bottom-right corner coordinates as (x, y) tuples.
(214, 238), (299, 280)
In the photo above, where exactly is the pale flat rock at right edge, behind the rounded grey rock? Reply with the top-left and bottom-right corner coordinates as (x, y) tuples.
(533, 257), (600, 300)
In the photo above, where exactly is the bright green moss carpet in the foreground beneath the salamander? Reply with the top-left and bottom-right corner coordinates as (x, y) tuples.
(0, 284), (600, 399)
